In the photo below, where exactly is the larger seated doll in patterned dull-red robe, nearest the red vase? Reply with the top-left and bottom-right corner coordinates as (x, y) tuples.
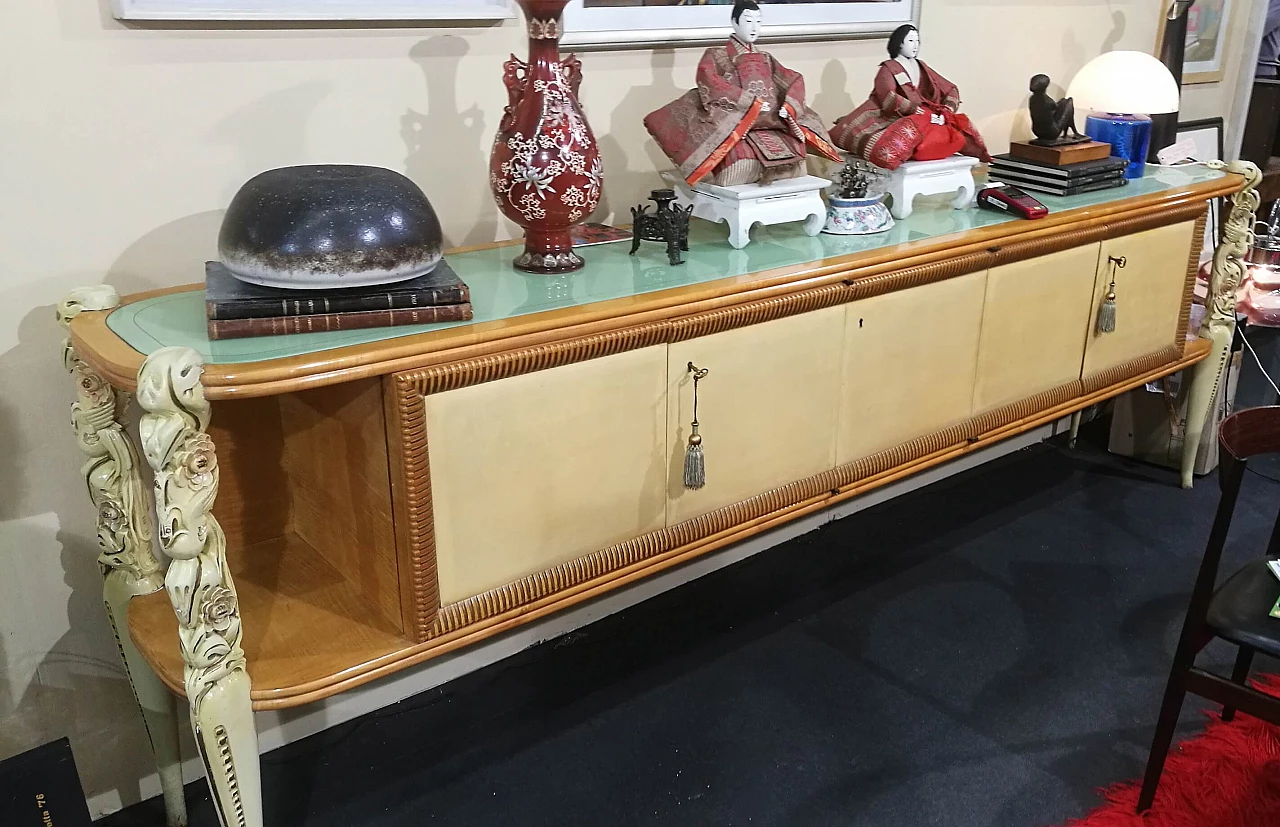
(644, 0), (844, 187)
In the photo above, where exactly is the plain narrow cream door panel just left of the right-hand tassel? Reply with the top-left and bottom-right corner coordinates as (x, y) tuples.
(973, 245), (1098, 414)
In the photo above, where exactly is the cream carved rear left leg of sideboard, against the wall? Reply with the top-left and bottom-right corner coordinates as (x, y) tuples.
(58, 285), (187, 827)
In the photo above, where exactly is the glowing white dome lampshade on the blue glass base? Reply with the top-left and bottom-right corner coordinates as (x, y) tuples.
(1066, 51), (1178, 115)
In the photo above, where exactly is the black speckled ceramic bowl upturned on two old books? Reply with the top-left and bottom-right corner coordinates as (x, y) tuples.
(218, 164), (443, 289)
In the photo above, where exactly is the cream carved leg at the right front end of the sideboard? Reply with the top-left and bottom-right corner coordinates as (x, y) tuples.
(1181, 161), (1262, 488)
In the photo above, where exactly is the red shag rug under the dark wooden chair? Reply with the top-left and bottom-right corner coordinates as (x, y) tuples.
(1068, 675), (1280, 827)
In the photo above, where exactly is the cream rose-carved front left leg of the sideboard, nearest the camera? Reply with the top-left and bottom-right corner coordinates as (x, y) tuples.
(138, 347), (262, 827)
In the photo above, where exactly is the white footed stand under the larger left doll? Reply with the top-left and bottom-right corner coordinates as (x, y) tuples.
(662, 172), (831, 250)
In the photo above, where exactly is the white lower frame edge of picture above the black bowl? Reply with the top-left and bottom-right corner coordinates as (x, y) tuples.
(111, 0), (515, 22)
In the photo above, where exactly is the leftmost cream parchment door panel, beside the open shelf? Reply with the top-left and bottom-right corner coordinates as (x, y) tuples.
(426, 346), (668, 604)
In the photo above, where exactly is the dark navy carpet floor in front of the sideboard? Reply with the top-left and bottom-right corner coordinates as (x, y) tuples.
(102, 427), (1280, 827)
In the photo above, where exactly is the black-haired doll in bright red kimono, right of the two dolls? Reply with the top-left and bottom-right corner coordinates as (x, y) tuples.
(831, 24), (991, 169)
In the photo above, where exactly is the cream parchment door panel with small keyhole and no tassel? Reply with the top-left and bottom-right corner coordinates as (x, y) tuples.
(836, 271), (987, 465)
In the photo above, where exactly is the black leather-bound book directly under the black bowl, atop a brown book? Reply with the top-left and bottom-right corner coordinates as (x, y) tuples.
(205, 260), (471, 319)
